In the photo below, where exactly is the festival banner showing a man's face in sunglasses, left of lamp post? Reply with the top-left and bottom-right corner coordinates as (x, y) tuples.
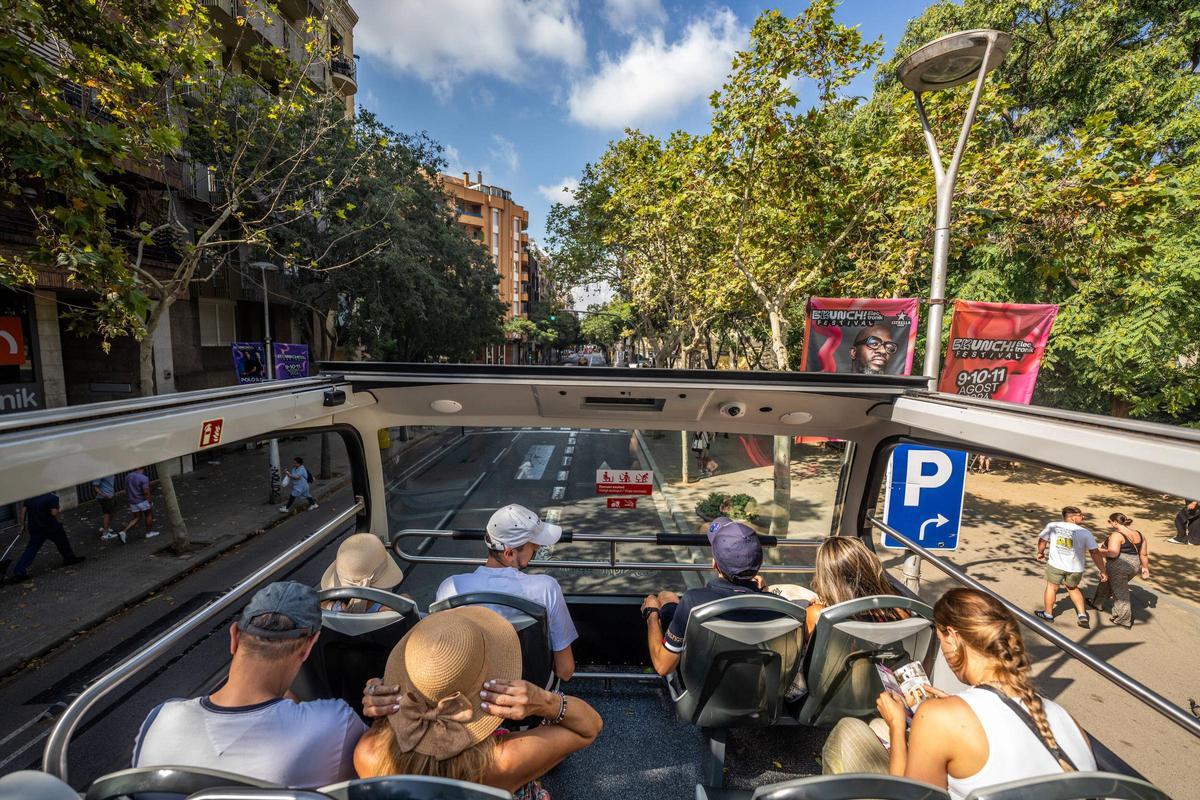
(800, 297), (917, 375)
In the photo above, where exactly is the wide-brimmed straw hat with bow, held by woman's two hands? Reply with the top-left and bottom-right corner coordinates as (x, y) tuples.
(383, 606), (521, 760)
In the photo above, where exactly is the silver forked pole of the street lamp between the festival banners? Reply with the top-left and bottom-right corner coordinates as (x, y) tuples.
(904, 35), (996, 591)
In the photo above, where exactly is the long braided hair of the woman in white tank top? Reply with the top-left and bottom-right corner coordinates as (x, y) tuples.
(934, 589), (1072, 770)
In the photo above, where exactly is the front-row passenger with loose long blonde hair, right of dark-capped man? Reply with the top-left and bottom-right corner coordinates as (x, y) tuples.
(782, 536), (907, 634)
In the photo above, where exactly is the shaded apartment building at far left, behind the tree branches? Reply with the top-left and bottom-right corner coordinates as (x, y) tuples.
(0, 0), (358, 424)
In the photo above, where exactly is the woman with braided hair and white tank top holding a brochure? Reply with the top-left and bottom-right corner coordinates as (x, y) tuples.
(823, 589), (1096, 800)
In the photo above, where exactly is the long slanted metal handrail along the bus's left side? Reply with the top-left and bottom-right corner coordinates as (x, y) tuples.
(42, 497), (366, 783)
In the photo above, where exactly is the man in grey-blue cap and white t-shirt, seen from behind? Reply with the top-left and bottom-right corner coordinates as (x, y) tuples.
(133, 582), (366, 788)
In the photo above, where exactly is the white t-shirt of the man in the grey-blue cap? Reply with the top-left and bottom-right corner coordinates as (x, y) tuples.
(133, 697), (367, 788)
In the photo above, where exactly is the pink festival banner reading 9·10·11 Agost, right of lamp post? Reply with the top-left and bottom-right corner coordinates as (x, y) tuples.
(937, 300), (1058, 404)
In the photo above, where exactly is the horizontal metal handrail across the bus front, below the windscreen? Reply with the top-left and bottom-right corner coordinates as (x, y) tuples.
(391, 528), (824, 575)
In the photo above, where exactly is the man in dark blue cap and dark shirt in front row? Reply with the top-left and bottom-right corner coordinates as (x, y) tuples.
(642, 517), (766, 676)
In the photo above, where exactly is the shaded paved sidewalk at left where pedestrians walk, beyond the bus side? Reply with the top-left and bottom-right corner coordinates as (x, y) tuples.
(0, 434), (434, 676)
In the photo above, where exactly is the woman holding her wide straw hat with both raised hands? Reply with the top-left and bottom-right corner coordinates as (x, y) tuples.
(354, 606), (604, 800)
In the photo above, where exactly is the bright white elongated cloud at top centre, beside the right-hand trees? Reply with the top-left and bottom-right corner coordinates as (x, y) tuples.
(568, 8), (748, 130)
